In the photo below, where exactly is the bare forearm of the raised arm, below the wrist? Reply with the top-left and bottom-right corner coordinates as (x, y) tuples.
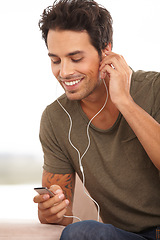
(118, 98), (160, 170)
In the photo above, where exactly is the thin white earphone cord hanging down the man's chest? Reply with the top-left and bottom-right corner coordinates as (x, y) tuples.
(57, 79), (108, 222)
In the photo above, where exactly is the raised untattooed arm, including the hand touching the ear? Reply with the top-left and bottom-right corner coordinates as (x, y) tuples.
(100, 51), (160, 170)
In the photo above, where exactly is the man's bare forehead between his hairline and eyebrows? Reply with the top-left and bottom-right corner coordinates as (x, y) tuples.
(47, 29), (96, 55)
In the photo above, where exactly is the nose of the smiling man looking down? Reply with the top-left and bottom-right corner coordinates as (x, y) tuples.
(59, 60), (74, 78)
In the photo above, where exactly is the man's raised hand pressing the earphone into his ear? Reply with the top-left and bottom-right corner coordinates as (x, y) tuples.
(100, 50), (132, 108)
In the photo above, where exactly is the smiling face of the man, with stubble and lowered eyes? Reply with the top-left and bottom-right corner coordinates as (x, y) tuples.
(47, 30), (100, 100)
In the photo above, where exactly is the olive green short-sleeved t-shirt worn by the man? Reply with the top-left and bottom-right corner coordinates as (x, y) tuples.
(40, 71), (160, 232)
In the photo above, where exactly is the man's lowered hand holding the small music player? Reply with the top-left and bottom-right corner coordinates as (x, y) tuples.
(33, 185), (71, 225)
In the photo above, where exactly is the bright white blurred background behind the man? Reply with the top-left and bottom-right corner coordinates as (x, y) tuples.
(0, 0), (160, 221)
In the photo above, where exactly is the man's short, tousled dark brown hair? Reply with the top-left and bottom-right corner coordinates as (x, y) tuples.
(39, 0), (113, 56)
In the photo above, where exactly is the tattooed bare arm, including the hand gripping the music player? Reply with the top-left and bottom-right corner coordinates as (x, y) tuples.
(34, 170), (75, 226)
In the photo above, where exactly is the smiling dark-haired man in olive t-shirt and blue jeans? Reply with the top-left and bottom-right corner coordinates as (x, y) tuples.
(34, 0), (160, 240)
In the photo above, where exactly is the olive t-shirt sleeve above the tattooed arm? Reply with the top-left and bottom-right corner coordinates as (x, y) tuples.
(39, 108), (74, 174)
